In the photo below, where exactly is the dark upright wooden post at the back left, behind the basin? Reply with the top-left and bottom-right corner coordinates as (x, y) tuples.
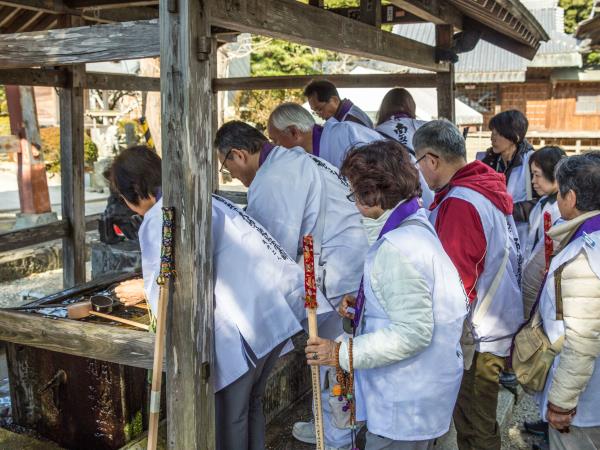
(59, 17), (85, 288)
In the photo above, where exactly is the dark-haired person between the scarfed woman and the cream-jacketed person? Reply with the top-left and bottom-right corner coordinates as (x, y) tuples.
(521, 146), (566, 319)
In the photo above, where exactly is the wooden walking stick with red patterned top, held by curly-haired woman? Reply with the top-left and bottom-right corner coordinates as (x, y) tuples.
(303, 234), (325, 450)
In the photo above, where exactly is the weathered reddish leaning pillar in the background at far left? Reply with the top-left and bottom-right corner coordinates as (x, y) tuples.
(6, 86), (51, 214)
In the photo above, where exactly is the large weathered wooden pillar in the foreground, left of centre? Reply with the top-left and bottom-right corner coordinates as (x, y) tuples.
(160, 0), (216, 450)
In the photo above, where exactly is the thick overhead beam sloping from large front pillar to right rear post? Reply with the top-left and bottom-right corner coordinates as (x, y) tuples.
(211, 0), (448, 72)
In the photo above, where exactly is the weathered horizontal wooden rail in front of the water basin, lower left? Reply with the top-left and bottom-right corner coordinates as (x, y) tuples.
(0, 309), (154, 369)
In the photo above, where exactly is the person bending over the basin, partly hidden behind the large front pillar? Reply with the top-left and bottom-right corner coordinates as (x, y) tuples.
(111, 147), (332, 450)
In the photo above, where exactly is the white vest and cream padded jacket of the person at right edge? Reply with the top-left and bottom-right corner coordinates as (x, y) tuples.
(537, 211), (600, 427)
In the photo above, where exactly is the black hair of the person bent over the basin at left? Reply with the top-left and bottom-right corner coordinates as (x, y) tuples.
(110, 145), (162, 205)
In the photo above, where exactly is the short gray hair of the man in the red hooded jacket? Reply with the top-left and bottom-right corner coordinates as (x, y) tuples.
(413, 119), (467, 161)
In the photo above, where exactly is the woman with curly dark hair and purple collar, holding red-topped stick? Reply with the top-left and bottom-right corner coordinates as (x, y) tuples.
(306, 141), (466, 450)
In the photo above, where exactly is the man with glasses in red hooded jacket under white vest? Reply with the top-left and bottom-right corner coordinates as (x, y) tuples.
(413, 120), (523, 450)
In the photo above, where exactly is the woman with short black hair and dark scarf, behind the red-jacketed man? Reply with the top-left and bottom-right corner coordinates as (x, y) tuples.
(476, 109), (539, 247)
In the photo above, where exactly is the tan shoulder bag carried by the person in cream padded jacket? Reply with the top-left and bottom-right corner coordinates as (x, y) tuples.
(511, 266), (564, 394)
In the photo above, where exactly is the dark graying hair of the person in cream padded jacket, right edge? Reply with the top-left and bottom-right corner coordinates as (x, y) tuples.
(556, 151), (600, 212)
